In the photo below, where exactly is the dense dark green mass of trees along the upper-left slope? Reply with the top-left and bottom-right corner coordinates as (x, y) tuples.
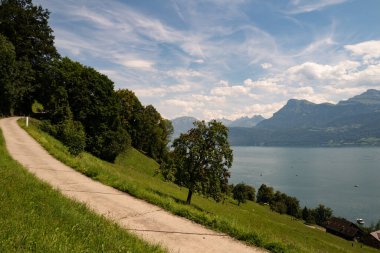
(0, 0), (173, 162)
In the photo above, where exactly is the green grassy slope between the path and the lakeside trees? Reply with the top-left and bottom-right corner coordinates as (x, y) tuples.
(21, 118), (378, 253)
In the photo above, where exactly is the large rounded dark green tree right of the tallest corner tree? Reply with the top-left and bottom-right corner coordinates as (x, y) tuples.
(46, 58), (130, 161)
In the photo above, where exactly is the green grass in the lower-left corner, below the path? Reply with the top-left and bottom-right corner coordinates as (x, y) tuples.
(0, 126), (164, 253)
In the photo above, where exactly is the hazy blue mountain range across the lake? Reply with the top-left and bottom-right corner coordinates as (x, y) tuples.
(172, 89), (380, 146)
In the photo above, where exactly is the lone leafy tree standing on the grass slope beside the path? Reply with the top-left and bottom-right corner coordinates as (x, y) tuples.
(173, 120), (233, 204)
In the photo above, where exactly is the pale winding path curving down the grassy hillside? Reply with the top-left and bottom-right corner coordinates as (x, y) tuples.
(0, 117), (266, 253)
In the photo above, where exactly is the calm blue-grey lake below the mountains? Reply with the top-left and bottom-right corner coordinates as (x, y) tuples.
(230, 147), (380, 226)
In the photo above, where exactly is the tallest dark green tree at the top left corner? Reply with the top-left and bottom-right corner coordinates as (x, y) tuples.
(0, 0), (59, 113)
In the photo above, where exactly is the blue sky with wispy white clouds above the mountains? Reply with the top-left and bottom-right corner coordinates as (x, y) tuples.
(33, 0), (380, 120)
